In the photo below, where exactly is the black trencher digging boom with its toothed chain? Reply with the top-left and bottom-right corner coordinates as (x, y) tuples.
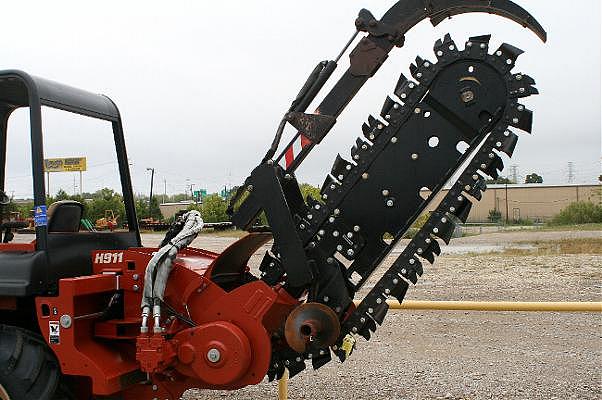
(268, 35), (537, 378)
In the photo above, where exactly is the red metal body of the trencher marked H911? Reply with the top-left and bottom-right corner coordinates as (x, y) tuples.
(36, 235), (299, 399)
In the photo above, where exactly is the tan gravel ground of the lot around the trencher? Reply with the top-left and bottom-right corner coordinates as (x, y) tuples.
(175, 230), (602, 400)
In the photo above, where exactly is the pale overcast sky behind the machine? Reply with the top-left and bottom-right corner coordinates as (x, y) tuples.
(0, 0), (601, 197)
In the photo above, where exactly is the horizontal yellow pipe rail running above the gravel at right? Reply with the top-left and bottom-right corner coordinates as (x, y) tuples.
(356, 300), (602, 312)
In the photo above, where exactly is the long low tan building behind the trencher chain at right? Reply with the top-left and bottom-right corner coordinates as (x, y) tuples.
(421, 183), (602, 222)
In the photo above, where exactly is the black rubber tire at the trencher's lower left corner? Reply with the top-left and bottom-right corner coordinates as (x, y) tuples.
(0, 324), (61, 400)
